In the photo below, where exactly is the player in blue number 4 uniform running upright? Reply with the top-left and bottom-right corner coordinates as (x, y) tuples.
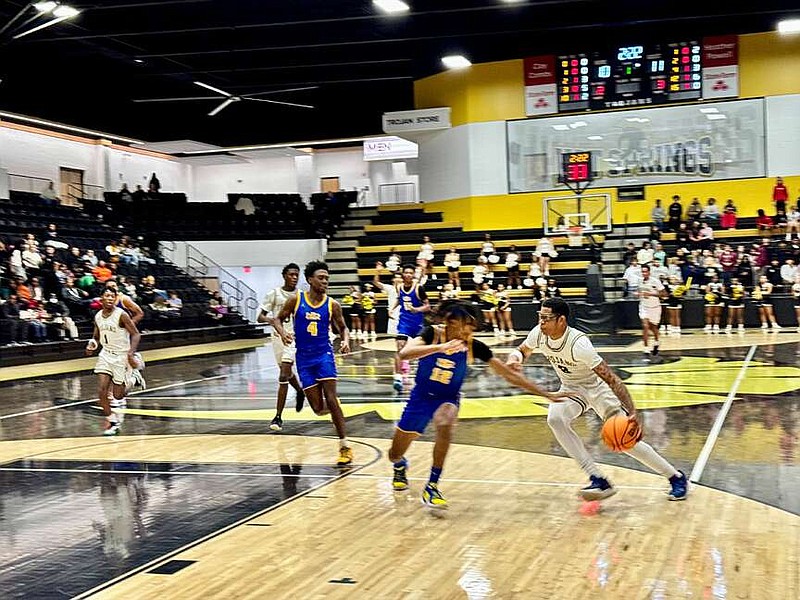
(273, 261), (353, 467)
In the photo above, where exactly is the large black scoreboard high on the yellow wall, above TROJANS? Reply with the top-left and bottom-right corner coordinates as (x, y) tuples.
(556, 41), (702, 112)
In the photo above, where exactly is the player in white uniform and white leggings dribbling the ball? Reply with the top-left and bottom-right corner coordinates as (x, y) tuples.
(506, 298), (688, 500)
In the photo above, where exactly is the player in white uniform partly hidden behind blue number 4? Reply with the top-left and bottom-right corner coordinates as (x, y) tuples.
(258, 263), (306, 431)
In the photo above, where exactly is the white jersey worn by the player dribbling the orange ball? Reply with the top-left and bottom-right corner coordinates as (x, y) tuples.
(522, 325), (603, 388)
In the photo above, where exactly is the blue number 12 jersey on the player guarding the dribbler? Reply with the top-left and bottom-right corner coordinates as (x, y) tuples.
(414, 325), (473, 398)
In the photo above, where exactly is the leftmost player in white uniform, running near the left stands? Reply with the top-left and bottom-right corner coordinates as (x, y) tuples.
(86, 288), (141, 435)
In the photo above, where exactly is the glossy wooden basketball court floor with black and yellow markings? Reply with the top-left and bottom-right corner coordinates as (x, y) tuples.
(0, 331), (800, 598)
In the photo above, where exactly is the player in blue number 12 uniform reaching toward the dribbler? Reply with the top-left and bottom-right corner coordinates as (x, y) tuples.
(389, 300), (564, 508)
